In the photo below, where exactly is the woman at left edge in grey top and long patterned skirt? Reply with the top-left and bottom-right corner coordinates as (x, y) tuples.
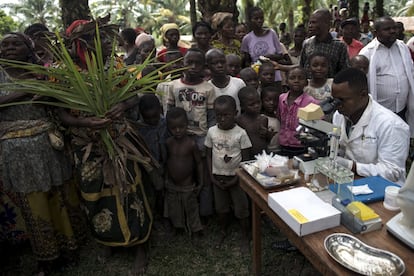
(0, 33), (78, 275)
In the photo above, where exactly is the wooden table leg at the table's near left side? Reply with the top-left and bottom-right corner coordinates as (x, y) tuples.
(252, 201), (262, 275)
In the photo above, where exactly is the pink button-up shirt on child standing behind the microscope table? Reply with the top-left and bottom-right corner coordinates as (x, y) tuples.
(277, 92), (319, 147)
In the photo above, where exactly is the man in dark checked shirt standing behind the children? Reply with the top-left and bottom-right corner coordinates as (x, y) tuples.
(300, 9), (349, 78)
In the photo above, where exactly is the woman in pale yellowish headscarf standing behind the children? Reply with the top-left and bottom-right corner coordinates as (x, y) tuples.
(211, 12), (241, 57)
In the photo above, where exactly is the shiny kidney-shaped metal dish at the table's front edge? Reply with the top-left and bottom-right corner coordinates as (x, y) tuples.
(325, 233), (405, 275)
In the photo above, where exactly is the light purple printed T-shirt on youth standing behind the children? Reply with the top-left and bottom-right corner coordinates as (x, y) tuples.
(240, 29), (282, 81)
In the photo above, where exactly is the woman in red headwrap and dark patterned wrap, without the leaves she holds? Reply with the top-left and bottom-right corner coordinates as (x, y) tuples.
(60, 18), (153, 273)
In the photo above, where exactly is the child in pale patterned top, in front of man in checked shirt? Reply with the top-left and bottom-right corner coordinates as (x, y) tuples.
(304, 53), (333, 101)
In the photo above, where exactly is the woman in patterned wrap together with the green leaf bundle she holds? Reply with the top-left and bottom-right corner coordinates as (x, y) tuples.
(60, 20), (156, 274)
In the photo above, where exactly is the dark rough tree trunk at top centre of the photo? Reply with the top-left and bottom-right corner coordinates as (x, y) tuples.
(197, 0), (239, 22)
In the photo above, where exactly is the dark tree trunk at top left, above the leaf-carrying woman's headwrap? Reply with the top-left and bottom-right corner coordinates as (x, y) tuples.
(59, 0), (91, 29)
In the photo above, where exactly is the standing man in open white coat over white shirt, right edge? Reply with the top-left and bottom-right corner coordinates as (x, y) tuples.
(359, 16), (414, 137)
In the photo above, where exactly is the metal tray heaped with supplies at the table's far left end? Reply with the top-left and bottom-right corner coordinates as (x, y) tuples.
(240, 160), (300, 189)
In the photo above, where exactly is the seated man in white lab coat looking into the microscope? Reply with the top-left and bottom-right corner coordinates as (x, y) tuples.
(332, 68), (410, 185)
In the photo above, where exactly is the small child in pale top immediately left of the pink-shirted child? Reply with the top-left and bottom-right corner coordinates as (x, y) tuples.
(260, 86), (280, 152)
